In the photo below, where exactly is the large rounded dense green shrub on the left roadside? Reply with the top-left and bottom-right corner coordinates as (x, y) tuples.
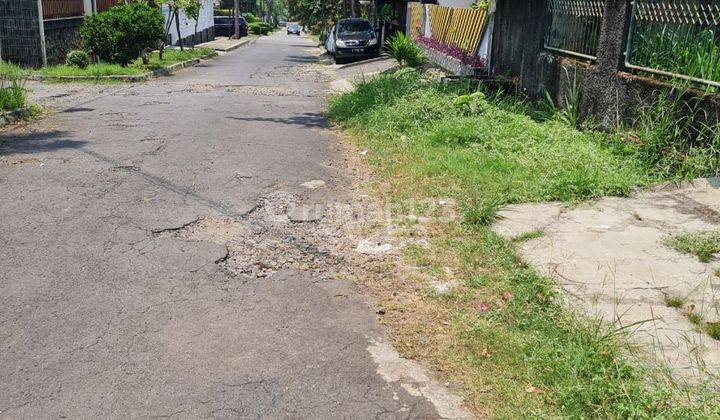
(80, 3), (165, 66)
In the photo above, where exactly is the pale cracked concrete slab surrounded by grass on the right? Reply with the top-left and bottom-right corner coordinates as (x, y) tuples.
(493, 180), (720, 376)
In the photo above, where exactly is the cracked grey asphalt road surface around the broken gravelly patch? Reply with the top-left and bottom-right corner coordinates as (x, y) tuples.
(0, 35), (450, 419)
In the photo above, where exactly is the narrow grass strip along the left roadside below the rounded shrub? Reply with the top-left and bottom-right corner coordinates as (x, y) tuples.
(0, 48), (215, 78)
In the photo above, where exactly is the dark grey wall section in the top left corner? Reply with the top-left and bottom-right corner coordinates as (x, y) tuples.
(0, 0), (43, 67)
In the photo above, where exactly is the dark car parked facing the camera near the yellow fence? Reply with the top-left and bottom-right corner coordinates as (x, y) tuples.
(326, 18), (380, 63)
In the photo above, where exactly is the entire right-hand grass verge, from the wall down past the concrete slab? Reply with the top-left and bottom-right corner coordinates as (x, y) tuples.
(329, 70), (720, 418)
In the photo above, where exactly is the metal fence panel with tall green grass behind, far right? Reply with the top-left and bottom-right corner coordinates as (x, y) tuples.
(625, 0), (720, 87)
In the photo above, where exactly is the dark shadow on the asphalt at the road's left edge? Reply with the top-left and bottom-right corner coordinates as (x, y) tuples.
(0, 130), (87, 155)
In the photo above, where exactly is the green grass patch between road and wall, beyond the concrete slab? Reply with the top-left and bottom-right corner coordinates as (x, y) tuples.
(330, 71), (654, 213)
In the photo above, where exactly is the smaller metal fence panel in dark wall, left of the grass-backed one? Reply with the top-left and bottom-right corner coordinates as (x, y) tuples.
(545, 0), (605, 60)
